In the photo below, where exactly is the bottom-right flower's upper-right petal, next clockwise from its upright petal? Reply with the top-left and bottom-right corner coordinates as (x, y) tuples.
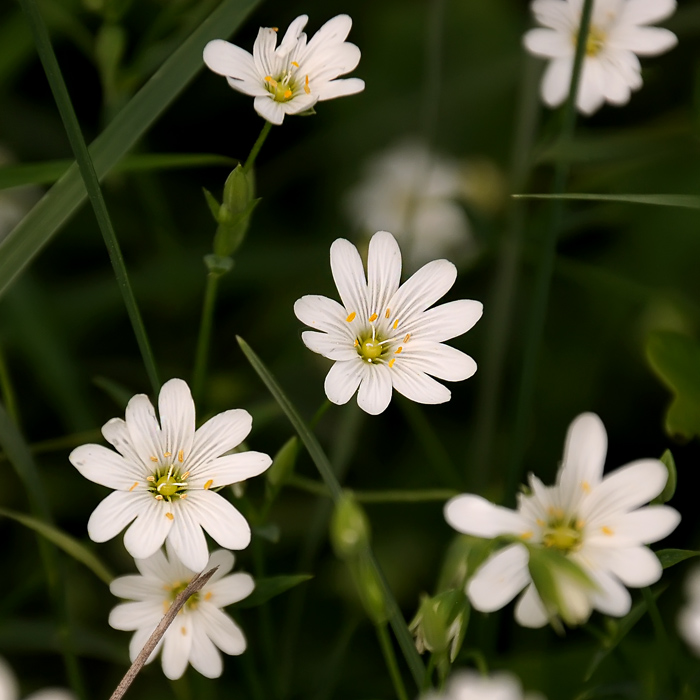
(581, 459), (668, 522)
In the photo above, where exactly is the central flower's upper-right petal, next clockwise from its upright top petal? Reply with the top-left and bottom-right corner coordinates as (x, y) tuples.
(388, 260), (457, 330)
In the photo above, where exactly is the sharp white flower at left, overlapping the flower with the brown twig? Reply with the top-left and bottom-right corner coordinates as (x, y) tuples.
(69, 379), (271, 571)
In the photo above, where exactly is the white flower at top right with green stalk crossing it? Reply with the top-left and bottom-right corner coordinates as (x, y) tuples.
(525, 0), (677, 114)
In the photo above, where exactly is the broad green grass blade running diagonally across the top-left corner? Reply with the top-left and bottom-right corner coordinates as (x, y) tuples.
(0, 0), (260, 295)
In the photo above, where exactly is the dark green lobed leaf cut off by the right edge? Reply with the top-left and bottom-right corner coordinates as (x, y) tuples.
(646, 331), (700, 441)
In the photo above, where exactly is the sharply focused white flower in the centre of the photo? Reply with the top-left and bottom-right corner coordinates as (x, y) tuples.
(294, 231), (482, 415)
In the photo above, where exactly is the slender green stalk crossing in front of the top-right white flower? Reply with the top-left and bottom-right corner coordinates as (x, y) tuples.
(505, 0), (593, 494)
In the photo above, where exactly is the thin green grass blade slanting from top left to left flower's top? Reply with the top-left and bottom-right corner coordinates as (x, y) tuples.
(20, 0), (160, 394)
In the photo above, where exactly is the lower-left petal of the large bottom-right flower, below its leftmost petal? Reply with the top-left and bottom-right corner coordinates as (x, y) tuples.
(467, 544), (530, 612)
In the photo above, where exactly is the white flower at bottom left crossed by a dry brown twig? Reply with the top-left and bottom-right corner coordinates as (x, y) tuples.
(109, 542), (255, 680)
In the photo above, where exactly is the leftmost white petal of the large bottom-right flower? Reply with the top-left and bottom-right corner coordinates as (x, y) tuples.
(444, 494), (531, 538)
